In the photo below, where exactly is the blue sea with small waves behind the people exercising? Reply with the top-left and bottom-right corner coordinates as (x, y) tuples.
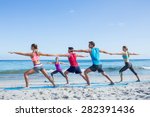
(0, 59), (150, 83)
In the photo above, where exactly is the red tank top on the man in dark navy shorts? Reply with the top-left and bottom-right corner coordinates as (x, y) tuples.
(68, 53), (78, 67)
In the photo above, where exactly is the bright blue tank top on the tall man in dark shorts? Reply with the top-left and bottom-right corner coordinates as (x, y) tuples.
(90, 48), (101, 65)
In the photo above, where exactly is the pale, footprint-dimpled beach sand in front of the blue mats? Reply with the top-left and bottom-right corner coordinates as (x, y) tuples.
(0, 76), (150, 100)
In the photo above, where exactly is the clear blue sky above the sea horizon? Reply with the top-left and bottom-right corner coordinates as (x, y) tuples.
(0, 0), (150, 59)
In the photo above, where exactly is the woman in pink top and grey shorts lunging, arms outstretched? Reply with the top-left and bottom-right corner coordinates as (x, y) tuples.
(9, 44), (55, 87)
